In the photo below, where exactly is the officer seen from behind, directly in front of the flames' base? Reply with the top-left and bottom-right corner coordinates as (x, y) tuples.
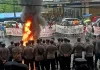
(23, 42), (34, 70)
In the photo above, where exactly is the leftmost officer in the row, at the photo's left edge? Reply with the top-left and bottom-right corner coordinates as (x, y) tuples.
(2, 44), (10, 63)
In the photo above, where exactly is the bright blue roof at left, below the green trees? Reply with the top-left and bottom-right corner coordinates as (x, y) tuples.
(0, 12), (21, 19)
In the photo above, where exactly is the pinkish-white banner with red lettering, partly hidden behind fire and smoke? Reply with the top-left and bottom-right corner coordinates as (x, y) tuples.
(6, 26), (55, 37)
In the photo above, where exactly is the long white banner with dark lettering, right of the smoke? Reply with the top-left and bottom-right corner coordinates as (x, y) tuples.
(56, 25), (83, 34)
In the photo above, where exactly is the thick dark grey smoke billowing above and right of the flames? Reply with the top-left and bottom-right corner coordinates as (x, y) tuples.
(19, 0), (46, 39)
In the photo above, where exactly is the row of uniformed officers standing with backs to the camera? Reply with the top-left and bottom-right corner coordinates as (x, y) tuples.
(0, 35), (100, 70)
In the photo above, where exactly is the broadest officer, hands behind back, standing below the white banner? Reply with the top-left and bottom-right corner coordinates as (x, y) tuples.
(59, 38), (72, 70)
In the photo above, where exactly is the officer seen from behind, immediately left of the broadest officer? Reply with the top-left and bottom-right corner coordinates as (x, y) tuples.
(46, 40), (57, 70)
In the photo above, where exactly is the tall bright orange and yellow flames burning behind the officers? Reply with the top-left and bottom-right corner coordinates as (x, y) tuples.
(22, 17), (34, 46)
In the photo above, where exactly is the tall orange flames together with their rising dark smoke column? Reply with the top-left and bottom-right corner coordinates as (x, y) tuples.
(20, 0), (45, 46)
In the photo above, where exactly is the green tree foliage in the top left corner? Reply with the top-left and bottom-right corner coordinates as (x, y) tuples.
(0, 0), (22, 13)
